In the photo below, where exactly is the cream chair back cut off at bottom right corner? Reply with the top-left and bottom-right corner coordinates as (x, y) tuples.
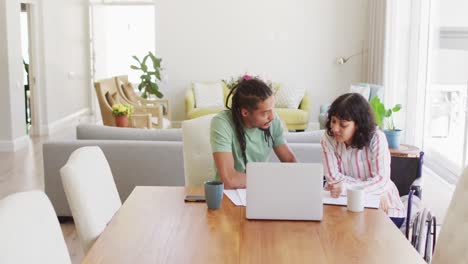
(432, 167), (468, 264)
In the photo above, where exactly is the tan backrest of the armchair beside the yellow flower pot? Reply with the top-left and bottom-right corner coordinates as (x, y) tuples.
(94, 78), (125, 126)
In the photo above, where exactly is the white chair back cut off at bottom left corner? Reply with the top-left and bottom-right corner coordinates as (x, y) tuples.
(0, 191), (71, 264)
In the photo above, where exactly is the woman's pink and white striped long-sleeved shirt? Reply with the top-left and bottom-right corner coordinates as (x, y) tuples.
(320, 129), (405, 217)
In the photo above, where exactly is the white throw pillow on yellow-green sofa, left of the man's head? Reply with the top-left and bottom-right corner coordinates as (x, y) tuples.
(193, 83), (224, 107)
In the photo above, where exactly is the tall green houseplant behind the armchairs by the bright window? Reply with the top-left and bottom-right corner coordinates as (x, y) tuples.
(130, 51), (164, 99)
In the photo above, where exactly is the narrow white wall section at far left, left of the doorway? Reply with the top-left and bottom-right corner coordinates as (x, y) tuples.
(0, 0), (26, 144)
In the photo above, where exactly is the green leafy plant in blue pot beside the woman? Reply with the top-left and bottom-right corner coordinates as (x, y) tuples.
(370, 96), (401, 148)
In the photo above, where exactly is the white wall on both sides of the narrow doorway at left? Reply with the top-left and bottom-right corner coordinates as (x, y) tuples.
(0, 0), (90, 146)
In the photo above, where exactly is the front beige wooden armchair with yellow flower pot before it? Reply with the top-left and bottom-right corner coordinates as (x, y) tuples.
(94, 78), (163, 128)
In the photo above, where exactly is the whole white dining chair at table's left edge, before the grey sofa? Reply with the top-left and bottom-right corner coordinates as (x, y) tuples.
(60, 147), (122, 253)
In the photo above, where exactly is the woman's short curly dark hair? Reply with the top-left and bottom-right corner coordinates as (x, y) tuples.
(326, 93), (376, 149)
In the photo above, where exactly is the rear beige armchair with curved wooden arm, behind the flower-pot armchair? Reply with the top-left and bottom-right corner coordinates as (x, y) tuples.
(114, 75), (170, 119)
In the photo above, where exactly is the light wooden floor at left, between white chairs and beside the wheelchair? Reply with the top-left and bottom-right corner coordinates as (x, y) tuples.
(0, 118), (453, 263)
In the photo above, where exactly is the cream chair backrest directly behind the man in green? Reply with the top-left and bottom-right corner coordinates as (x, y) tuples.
(182, 115), (215, 186)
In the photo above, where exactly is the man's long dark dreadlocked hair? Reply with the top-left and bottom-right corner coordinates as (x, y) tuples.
(226, 78), (274, 165)
